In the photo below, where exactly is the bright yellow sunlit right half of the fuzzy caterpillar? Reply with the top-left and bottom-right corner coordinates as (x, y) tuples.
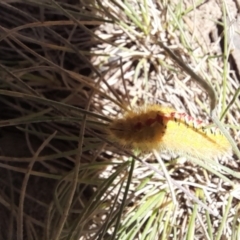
(159, 120), (231, 158)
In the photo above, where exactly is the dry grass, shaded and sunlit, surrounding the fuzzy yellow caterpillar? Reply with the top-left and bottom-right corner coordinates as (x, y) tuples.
(0, 0), (240, 240)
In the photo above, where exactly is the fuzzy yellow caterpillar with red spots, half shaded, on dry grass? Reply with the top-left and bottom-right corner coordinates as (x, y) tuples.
(108, 104), (231, 159)
